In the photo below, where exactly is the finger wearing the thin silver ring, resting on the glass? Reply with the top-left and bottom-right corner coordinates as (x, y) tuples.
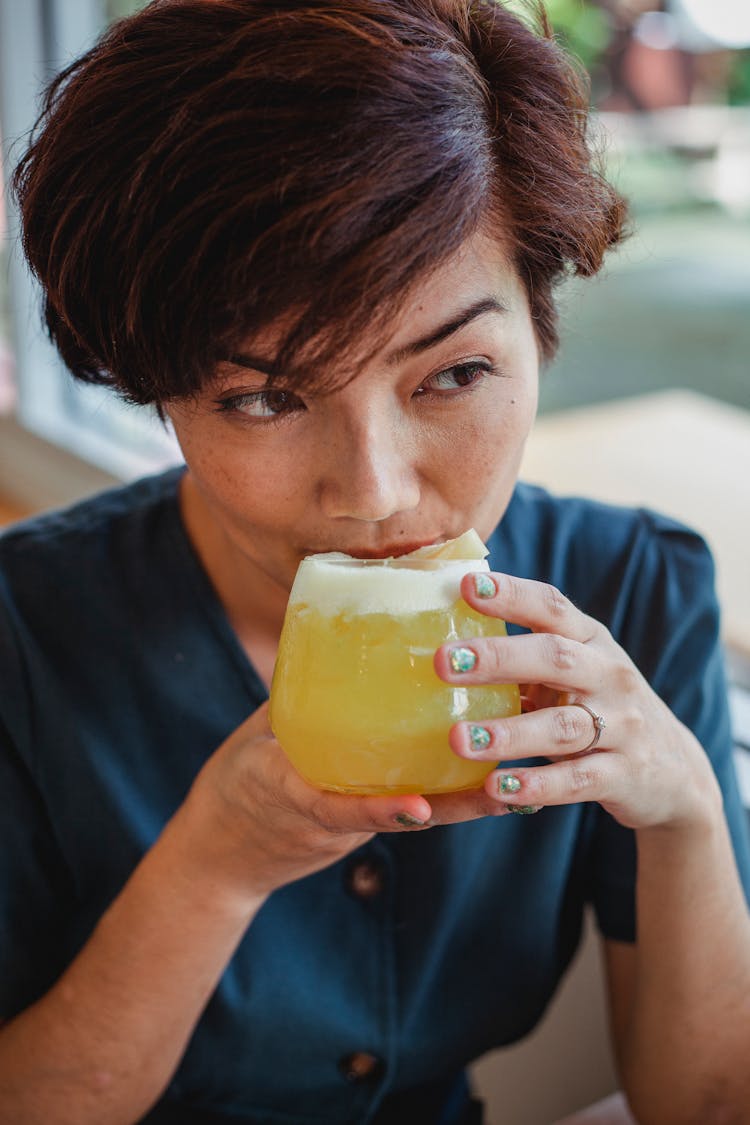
(448, 707), (605, 762)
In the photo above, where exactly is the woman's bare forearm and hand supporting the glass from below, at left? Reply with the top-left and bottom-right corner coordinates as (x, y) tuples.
(0, 705), (427, 1125)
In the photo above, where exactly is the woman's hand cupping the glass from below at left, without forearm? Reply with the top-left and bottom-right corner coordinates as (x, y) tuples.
(181, 703), (432, 899)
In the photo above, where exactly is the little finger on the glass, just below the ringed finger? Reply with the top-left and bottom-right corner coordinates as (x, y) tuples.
(485, 750), (618, 808)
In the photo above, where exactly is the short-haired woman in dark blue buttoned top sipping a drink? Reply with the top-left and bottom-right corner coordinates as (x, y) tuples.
(0, 0), (750, 1125)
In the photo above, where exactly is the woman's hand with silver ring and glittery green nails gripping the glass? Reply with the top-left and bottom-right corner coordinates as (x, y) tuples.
(430, 574), (721, 828)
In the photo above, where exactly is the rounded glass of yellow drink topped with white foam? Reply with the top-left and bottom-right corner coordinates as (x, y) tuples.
(271, 556), (521, 793)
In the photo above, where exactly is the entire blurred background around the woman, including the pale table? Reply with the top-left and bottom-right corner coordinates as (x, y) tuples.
(0, 0), (750, 1125)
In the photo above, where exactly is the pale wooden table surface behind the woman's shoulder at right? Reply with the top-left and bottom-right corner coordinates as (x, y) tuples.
(522, 390), (750, 656)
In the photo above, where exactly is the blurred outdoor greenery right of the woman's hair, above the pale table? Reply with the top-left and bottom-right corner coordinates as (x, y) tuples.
(532, 0), (750, 410)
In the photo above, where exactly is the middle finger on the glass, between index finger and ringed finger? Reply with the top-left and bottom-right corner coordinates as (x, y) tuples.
(434, 633), (604, 695)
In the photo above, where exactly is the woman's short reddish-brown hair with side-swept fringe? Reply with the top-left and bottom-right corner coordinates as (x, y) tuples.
(15, 0), (625, 404)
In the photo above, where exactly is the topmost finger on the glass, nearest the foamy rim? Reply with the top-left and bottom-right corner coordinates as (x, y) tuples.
(461, 572), (603, 644)
